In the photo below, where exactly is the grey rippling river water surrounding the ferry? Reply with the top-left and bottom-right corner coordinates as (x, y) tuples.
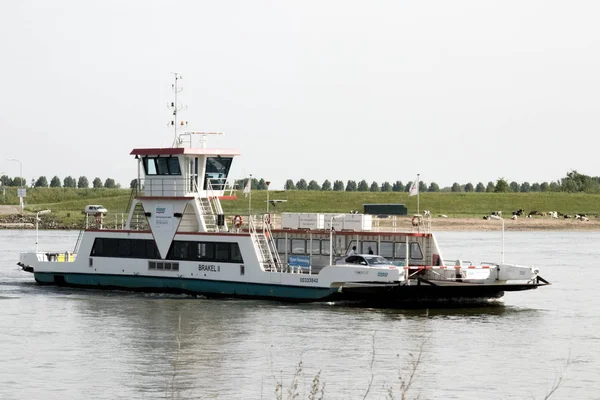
(0, 231), (600, 399)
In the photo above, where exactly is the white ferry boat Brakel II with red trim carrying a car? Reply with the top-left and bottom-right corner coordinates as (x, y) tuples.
(18, 81), (549, 307)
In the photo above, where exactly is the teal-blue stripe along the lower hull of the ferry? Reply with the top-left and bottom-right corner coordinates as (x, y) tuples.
(34, 272), (337, 301)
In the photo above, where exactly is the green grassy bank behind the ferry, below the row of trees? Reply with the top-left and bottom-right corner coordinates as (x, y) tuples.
(0, 188), (600, 225)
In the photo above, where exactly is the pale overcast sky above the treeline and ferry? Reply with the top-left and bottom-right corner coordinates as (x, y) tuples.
(0, 0), (600, 189)
